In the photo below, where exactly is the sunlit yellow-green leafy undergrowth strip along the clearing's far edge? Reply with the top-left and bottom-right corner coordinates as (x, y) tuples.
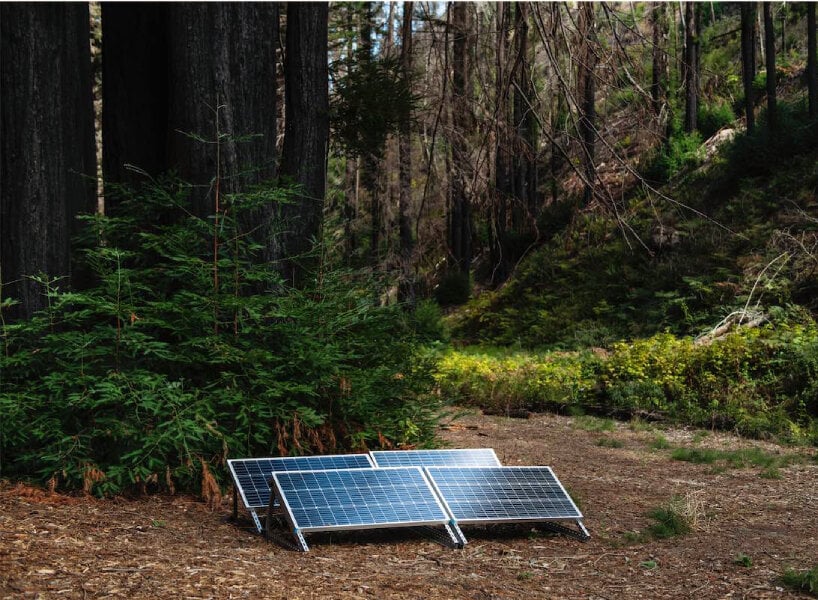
(436, 321), (818, 444)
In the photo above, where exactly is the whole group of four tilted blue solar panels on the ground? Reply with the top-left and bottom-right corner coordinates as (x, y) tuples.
(228, 448), (590, 551)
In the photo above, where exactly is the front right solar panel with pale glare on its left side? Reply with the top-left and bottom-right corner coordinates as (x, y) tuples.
(426, 467), (588, 539)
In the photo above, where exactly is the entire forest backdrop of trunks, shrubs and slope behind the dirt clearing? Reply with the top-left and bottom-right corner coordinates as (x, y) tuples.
(0, 2), (818, 495)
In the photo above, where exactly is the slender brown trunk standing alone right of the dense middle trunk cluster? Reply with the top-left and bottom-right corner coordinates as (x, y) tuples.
(577, 2), (597, 206)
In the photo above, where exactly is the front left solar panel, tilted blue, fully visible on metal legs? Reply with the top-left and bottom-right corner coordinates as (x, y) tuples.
(268, 467), (461, 551)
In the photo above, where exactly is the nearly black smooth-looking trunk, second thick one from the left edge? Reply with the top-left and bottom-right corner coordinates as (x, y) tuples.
(102, 2), (168, 192)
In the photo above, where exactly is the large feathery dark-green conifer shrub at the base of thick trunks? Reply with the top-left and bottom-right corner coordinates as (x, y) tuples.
(0, 183), (437, 494)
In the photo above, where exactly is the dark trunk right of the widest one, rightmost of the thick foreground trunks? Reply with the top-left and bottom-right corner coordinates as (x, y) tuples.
(279, 2), (329, 285)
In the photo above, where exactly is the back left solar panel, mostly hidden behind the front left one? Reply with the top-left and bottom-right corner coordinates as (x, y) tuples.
(227, 454), (373, 532)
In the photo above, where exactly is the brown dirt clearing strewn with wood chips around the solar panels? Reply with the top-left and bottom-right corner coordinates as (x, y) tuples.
(0, 414), (818, 600)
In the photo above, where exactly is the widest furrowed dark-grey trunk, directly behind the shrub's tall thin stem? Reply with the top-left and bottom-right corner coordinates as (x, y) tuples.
(167, 2), (278, 223)
